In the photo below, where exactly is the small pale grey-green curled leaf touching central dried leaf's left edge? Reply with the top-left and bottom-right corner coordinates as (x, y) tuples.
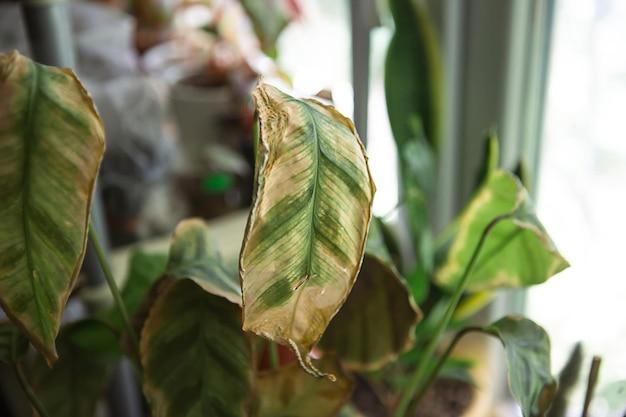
(165, 219), (241, 305)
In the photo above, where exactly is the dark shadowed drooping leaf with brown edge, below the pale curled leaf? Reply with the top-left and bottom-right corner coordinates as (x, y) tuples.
(140, 279), (252, 417)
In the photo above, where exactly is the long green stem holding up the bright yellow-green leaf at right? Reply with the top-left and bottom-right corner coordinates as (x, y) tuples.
(394, 212), (515, 417)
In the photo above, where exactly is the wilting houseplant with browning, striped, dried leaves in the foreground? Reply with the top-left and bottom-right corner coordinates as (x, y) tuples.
(0, 52), (567, 417)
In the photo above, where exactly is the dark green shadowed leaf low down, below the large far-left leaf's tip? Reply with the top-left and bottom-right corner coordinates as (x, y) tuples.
(30, 320), (121, 417)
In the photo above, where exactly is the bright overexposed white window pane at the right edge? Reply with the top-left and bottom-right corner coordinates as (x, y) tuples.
(528, 0), (626, 415)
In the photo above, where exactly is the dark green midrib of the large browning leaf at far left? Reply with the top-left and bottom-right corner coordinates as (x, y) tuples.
(22, 61), (50, 339)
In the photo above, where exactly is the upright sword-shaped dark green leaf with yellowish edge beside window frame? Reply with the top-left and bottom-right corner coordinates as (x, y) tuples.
(385, 0), (442, 152)
